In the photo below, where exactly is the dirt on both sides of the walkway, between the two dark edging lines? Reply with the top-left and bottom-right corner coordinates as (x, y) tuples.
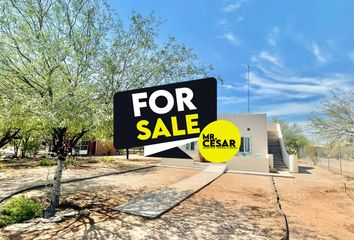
(0, 167), (284, 239)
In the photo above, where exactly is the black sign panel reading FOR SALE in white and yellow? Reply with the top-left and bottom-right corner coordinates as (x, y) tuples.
(114, 78), (216, 149)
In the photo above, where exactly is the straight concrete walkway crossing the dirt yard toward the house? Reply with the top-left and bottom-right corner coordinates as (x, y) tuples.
(113, 164), (226, 218)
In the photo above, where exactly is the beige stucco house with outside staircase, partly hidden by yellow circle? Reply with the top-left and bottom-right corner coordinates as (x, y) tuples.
(174, 114), (297, 172)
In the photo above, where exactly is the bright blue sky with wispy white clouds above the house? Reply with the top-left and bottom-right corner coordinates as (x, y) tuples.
(111, 0), (354, 124)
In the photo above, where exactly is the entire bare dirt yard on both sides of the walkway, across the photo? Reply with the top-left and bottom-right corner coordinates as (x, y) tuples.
(0, 158), (354, 239)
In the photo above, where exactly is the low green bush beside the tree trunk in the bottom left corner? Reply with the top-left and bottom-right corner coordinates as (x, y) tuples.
(0, 196), (43, 227)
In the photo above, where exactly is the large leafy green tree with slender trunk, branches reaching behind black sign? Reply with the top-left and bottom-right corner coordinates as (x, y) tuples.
(0, 0), (208, 217)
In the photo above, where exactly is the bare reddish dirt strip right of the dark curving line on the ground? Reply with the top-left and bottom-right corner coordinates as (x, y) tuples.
(275, 166), (354, 239)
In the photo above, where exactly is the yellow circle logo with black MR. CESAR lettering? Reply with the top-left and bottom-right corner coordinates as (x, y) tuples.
(198, 120), (241, 163)
